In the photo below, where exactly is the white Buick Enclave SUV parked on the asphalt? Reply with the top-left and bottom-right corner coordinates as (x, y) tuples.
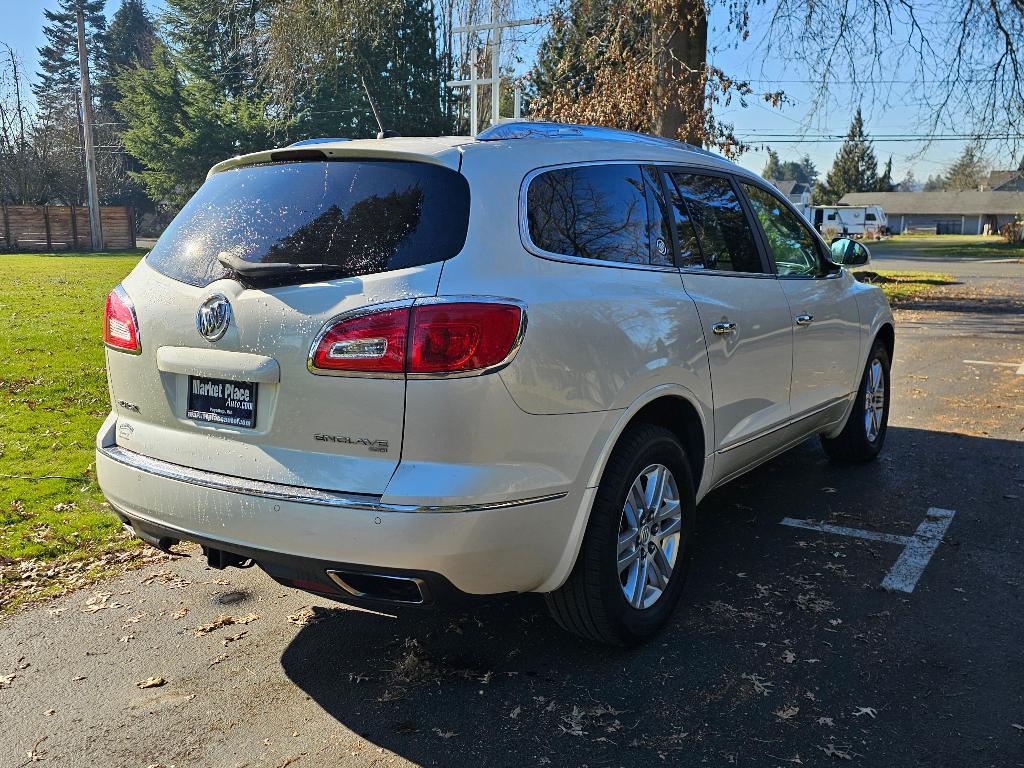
(96, 123), (894, 644)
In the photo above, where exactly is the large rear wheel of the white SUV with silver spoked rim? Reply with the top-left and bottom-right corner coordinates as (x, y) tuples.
(545, 424), (696, 645)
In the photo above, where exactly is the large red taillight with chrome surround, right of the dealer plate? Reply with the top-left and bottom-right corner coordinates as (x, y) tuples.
(311, 302), (523, 374)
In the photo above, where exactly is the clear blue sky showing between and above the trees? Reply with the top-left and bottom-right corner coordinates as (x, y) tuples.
(0, 0), (1011, 181)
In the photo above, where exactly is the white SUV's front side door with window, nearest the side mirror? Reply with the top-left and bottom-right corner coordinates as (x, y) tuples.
(741, 181), (861, 426)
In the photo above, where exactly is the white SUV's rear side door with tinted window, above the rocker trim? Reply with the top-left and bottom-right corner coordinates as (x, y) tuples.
(664, 168), (793, 481)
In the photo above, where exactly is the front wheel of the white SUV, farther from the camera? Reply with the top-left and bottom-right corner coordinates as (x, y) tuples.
(821, 341), (890, 464)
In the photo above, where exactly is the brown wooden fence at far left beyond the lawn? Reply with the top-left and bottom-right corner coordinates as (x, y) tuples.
(0, 205), (135, 252)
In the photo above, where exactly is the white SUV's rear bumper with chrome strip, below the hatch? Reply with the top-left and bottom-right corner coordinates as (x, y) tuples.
(96, 425), (581, 602)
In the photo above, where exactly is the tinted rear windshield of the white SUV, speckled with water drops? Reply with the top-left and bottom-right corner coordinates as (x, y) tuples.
(146, 160), (469, 287)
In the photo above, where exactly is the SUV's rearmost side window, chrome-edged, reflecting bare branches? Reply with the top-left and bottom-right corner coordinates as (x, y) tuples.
(526, 165), (650, 264)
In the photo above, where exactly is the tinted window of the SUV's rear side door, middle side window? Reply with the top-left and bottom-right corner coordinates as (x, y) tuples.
(671, 172), (764, 272)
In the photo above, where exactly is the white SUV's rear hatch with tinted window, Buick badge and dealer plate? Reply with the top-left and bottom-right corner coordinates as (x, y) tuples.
(108, 144), (469, 495)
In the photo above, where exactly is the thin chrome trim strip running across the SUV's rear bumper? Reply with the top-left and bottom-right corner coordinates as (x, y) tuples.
(97, 445), (567, 512)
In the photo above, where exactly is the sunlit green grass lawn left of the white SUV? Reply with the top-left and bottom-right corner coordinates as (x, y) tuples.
(0, 251), (143, 610)
